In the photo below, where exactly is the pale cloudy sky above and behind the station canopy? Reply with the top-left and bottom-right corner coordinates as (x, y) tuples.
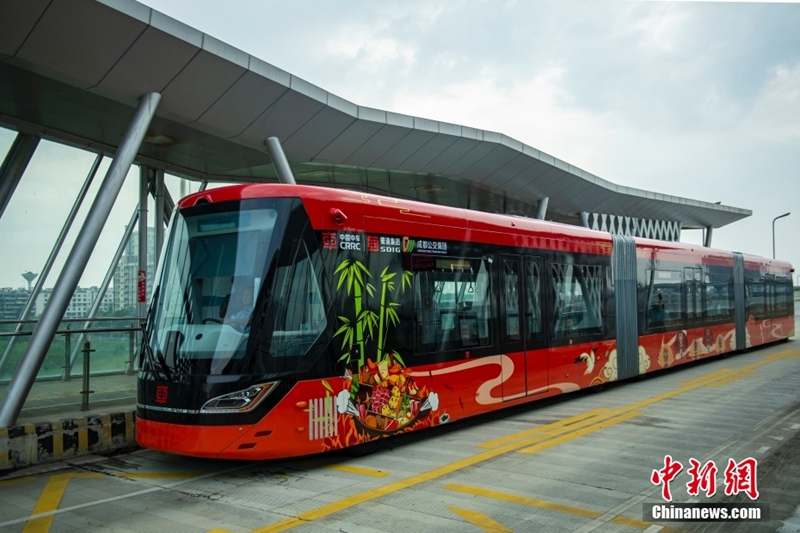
(0, 0), (800, 287)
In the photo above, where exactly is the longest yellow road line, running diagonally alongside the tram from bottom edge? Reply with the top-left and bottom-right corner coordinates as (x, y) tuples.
(245, 352), (788, 533)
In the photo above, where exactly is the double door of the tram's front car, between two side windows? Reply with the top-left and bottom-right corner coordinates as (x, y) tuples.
(500, 255), (548, 401)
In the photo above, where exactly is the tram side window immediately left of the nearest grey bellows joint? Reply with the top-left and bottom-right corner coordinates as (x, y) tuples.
(552, 263), (603, 339)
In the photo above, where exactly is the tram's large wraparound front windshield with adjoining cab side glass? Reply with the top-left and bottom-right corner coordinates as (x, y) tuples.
(144, 198), (326, 380)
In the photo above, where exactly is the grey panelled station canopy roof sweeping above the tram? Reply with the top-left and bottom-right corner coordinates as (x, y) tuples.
(0, 0), (752, 228)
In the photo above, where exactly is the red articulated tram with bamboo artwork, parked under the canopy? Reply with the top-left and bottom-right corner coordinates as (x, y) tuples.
(136, 185), (794, 459)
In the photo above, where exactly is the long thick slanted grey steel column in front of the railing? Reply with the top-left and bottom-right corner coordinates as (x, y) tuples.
(0, 93), (161, 427)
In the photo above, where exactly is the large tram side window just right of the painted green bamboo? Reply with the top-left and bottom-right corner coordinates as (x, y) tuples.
(413, 256), (492, 354)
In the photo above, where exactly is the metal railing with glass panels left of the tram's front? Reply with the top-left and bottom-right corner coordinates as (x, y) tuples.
(0, 316), (143, 384)
